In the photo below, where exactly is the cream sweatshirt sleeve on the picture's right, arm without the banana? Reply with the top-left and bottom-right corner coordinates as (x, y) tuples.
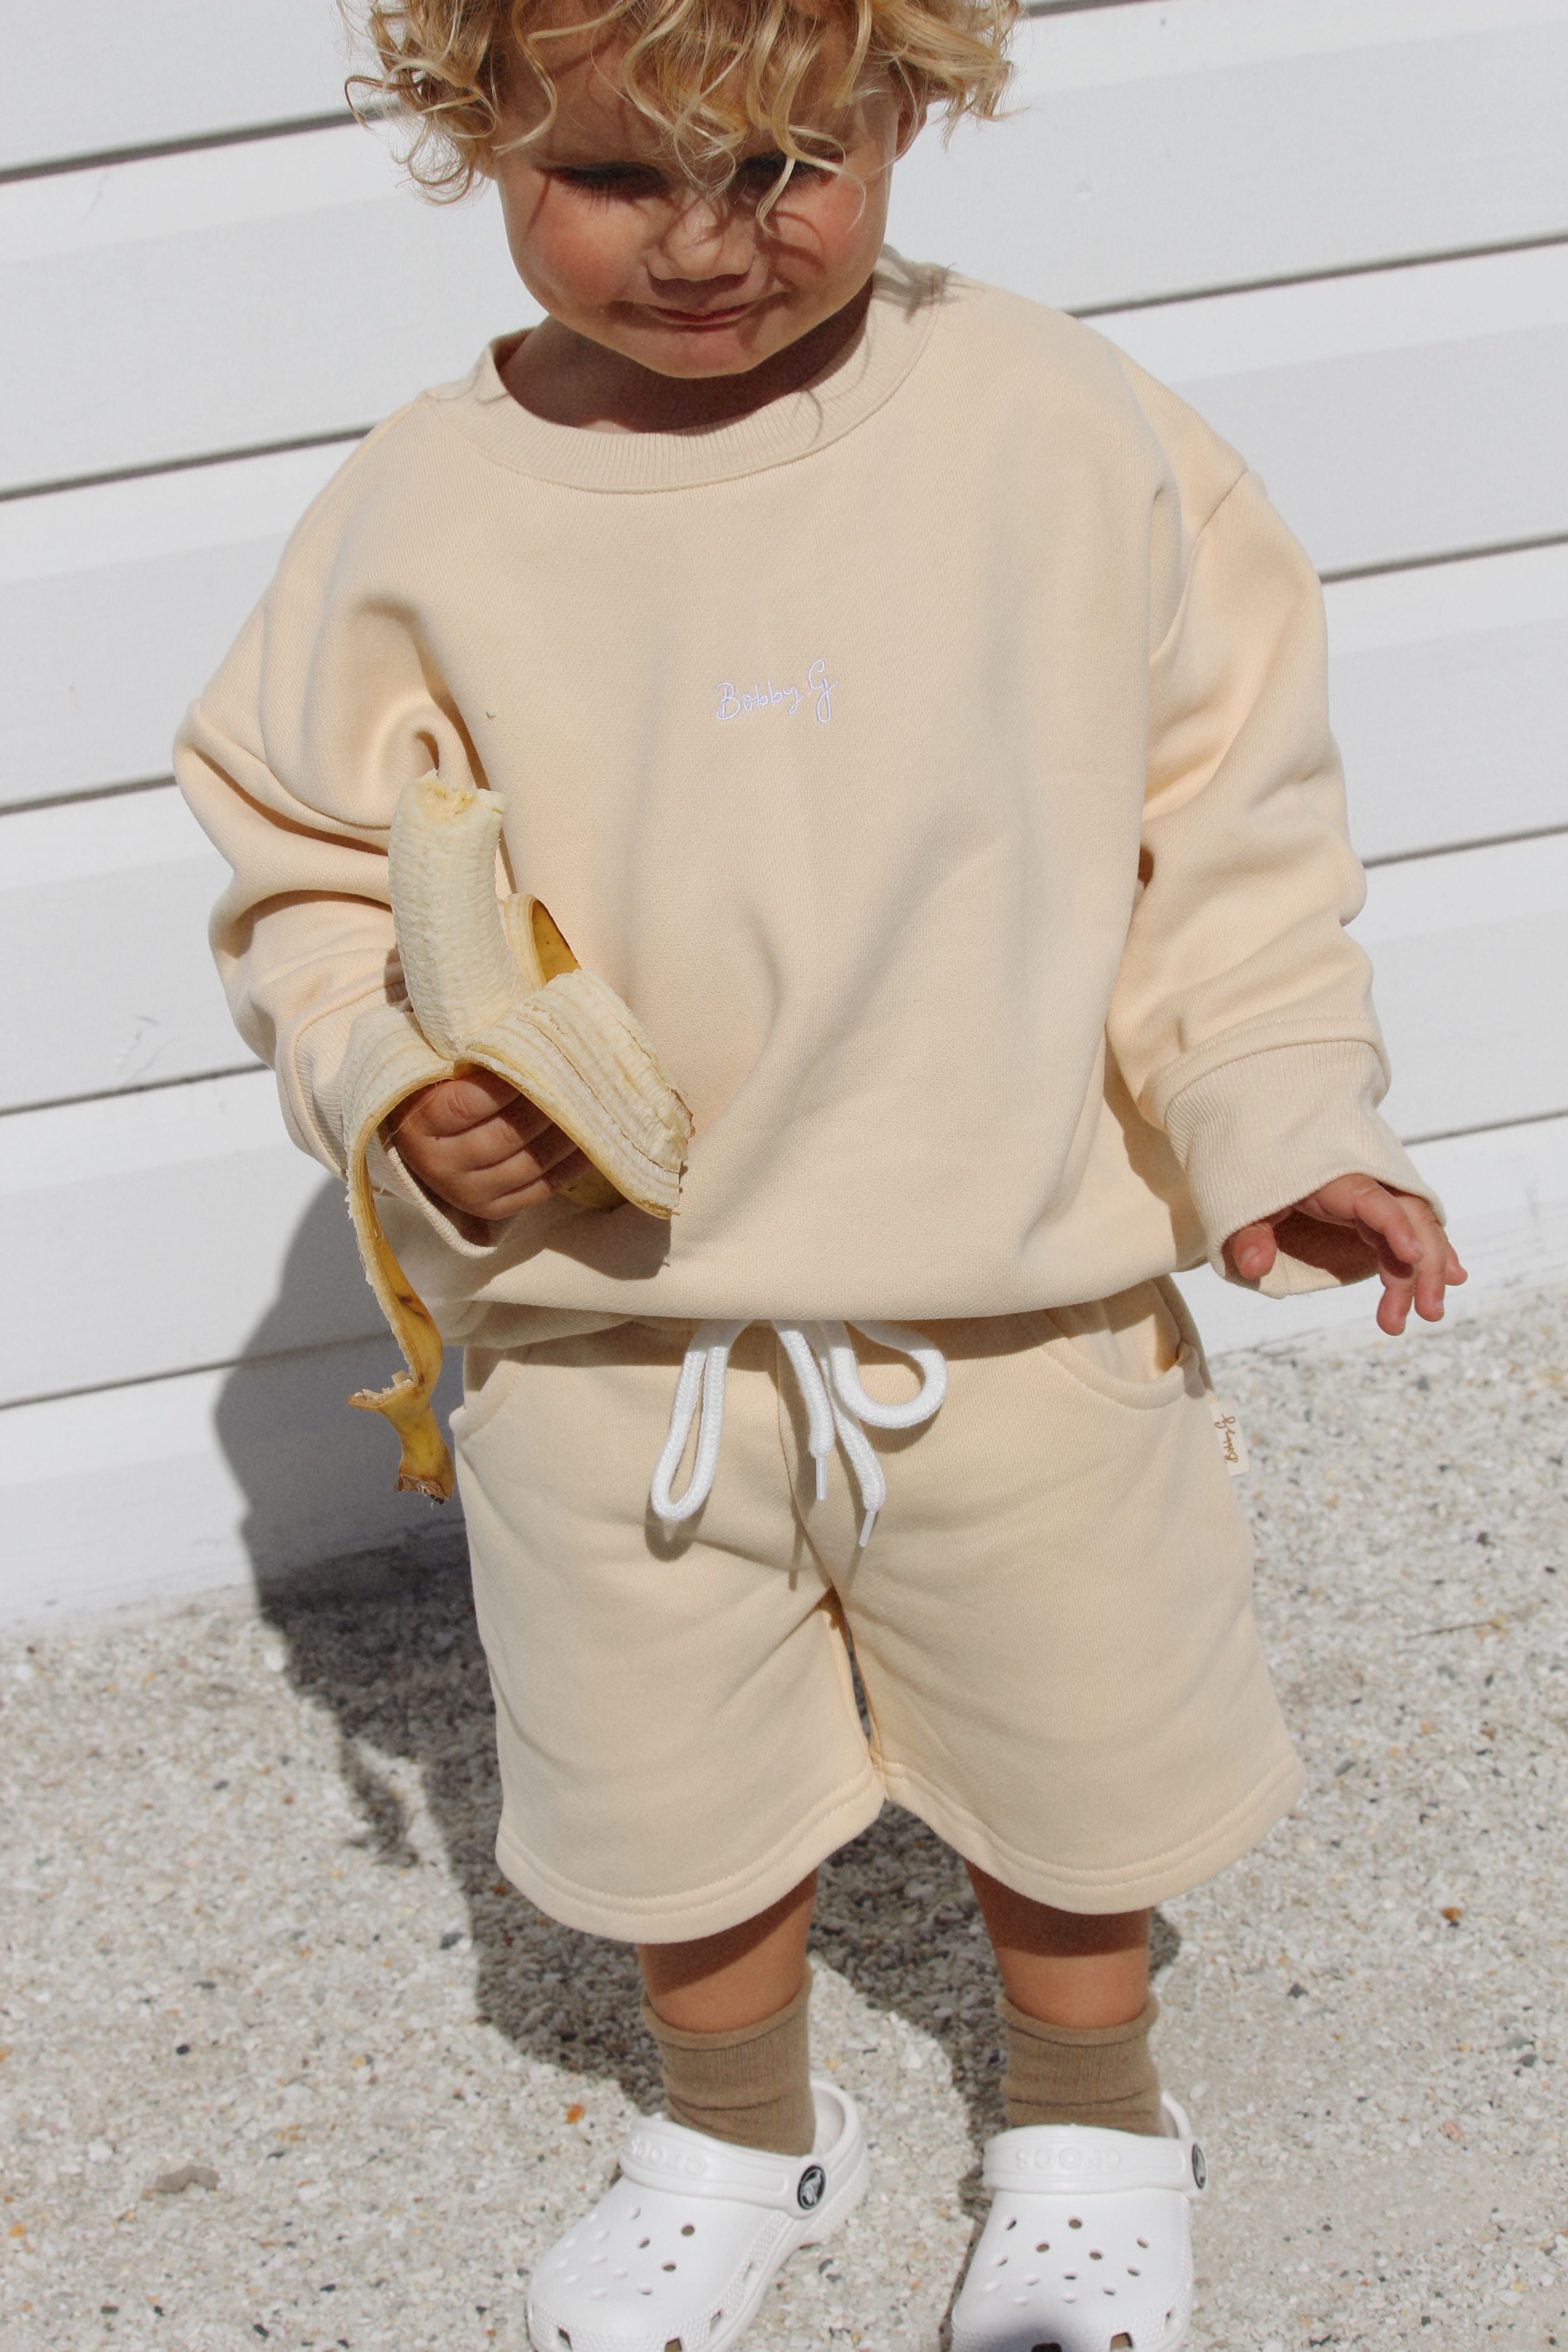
(1110, 458), (1441, 1294)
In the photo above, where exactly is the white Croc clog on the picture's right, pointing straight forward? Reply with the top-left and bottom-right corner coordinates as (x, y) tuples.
(952, 2098), (1208, 2352)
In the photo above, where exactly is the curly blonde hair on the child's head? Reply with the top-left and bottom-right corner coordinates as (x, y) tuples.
(338, 0), (1020, 197)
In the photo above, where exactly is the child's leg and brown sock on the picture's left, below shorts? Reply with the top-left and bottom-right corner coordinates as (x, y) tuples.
(637, 1872), (816, 2157)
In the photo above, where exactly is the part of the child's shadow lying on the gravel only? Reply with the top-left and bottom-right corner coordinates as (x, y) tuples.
(261, 1562), (1178, 2140)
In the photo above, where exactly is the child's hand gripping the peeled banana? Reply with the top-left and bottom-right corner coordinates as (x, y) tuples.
(381, 1070), (588, 1218)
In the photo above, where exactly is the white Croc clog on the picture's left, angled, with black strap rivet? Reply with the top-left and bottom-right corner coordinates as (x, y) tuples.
(529, 2082), (870, 2352)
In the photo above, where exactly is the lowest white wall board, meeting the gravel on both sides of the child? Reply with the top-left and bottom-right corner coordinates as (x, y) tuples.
(0, 1120), (1568, 1623)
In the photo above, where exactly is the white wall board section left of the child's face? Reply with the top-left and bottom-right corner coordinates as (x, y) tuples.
(0, 125), (539, 487)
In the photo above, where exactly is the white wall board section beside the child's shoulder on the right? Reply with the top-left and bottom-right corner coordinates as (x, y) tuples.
(1098, 245), (1568, 572)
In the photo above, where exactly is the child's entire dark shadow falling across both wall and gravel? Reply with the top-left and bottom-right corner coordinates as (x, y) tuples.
(219, 1188), (1178, 2190)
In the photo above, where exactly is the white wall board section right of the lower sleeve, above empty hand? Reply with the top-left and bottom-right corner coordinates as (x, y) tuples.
(1354, 835), (1568, 1136)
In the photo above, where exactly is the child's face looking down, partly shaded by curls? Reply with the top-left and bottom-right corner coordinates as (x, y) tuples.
(491, 8), (912, 379)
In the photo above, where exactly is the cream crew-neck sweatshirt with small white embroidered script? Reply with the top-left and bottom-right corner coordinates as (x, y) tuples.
(176, 254), (1427, 1343)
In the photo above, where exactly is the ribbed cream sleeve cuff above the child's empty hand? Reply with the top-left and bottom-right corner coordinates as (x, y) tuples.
(1166, 1039), (1443, 1298)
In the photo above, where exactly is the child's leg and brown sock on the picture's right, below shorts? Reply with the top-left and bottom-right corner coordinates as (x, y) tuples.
(969, 1863), (1161, 2136)
